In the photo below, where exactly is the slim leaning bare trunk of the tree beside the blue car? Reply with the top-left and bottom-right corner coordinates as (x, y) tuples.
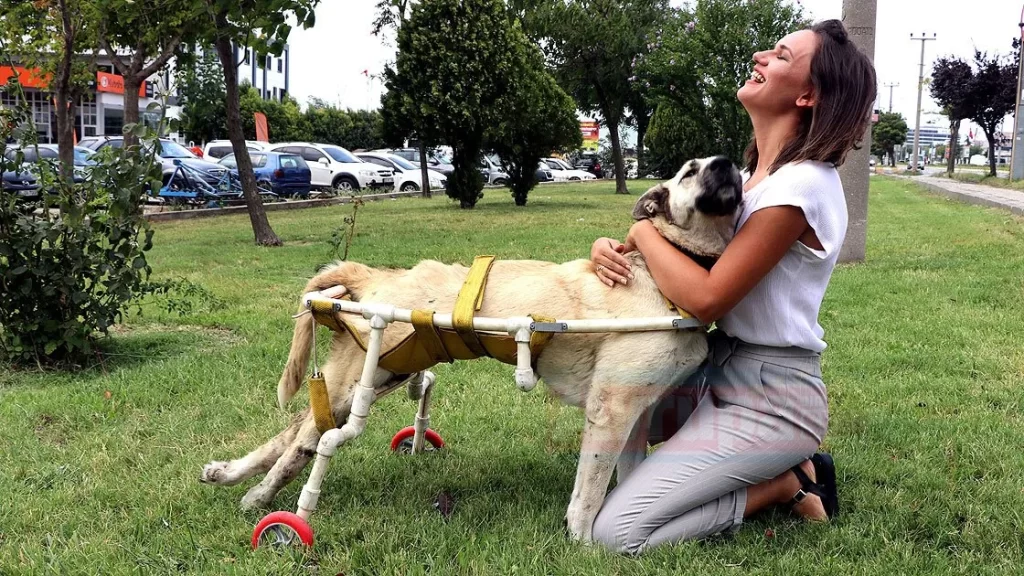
(215, 31), (282, 246)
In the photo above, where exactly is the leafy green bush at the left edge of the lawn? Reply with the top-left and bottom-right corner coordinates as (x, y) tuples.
(0, 99), (161, 364)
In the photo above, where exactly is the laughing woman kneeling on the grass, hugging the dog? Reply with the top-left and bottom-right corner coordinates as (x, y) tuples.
(591, 20), (876, 552)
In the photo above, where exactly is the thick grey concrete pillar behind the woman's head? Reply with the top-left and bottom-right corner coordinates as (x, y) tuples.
(839, 0), (878, 262)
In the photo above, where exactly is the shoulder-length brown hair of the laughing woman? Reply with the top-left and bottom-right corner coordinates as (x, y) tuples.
(745, 19), (878, 174)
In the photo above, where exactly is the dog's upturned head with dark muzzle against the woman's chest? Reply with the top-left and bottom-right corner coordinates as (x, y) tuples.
(633, 156), (743, 256)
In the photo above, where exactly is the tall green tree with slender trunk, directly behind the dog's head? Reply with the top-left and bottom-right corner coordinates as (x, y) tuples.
(537, 0), (669, 194)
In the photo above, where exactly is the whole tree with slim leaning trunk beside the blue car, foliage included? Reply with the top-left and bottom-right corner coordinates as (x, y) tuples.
(197, 0), (319, 246)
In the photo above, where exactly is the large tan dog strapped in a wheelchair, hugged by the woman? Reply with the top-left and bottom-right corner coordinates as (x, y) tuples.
(201, 158), (742, 540)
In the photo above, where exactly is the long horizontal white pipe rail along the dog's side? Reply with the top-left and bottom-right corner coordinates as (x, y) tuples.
(303, 292), (700, 334)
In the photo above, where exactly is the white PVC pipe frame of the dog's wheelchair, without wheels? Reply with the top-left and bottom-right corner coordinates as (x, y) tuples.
(297, 286), (700, 521)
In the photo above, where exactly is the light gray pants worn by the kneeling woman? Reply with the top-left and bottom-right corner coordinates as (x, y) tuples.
(594, 331), (828, 552)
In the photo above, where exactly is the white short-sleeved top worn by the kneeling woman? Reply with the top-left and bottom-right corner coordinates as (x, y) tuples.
(717, 161), (847, 352)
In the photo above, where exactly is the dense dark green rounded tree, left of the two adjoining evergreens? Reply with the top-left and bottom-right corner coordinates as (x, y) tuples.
(383, 0), (523, 208)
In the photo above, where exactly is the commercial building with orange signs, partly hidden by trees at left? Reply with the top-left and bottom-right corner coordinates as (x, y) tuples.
(0, 40), (290, 143)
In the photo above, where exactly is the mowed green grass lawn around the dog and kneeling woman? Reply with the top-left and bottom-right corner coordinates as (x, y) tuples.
(0, 177), (1024, 576)
